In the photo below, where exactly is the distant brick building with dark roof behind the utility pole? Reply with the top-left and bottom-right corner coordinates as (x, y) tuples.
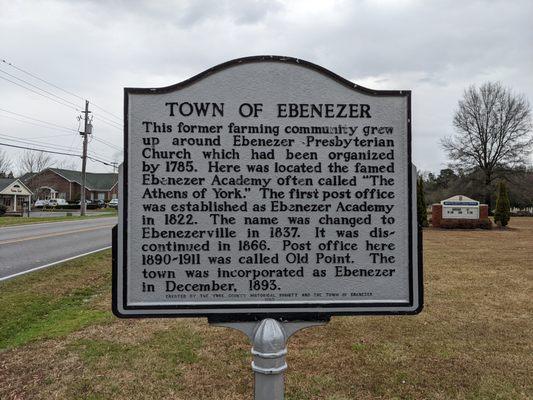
(20, 168), (118, 202)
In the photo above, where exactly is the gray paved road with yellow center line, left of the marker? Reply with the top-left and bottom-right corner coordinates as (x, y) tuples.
(0, 217), (117, 281)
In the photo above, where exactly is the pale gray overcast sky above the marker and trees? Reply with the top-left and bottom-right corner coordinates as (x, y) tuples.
(0, 0), (533, 172)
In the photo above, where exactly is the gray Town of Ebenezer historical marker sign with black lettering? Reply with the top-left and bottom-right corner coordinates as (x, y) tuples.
(113, 57), (422, 319)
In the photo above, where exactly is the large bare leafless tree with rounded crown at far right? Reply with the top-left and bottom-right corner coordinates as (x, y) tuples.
(442, 82), (533, 209)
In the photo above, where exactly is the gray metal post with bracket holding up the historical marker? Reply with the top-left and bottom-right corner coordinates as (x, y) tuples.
(212, 318), (329, 400)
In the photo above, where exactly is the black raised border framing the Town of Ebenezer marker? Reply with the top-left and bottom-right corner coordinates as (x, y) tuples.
(112, 56), (423, 322)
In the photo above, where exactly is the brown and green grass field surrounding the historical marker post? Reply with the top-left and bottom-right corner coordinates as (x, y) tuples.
(0, 218), (533, 400)
